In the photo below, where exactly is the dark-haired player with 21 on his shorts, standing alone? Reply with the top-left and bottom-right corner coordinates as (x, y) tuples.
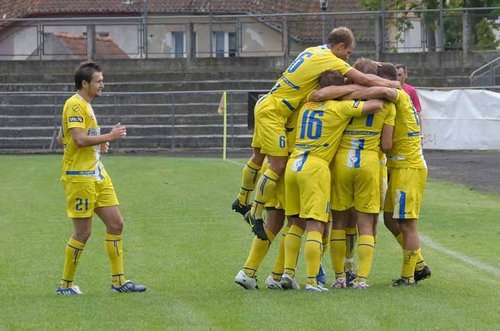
(56, 62), (146, 295)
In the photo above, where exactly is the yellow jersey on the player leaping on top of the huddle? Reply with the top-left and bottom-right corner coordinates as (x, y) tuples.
(268, 45), (352, 118)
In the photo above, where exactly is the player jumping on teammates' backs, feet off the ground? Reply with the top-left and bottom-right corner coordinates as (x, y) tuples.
(232, 27), (400, 239)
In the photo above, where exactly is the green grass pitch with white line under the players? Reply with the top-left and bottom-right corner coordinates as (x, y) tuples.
(0, 155), (500, 330)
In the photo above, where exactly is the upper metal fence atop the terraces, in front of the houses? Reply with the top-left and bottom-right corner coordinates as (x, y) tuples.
(0, 7), (500, 60)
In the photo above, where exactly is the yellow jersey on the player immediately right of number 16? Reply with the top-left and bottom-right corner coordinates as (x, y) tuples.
(339, 101), (396, 153)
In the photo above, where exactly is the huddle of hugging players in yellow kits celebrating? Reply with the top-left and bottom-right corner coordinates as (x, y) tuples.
(232, 27), (431, 292)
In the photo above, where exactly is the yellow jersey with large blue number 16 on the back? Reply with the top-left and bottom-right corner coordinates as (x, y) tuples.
(290, 100), (364, 166)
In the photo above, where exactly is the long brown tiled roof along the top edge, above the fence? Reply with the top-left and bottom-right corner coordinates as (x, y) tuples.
(0, 0), (373, 41)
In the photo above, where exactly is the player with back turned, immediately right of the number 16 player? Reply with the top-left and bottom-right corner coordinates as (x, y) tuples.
(330, 59), (396, 289)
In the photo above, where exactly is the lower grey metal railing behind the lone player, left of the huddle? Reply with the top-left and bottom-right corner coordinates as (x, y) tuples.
(0, 91), (252, 153)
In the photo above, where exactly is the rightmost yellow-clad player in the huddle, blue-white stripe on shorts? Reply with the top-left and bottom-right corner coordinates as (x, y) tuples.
(378, 63), (431, 286)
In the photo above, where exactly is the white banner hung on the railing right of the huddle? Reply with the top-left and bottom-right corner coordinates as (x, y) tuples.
(417, 89), (500, 150)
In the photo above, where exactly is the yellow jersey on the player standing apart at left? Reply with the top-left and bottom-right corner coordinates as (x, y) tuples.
(61, 94), (107, 182)
